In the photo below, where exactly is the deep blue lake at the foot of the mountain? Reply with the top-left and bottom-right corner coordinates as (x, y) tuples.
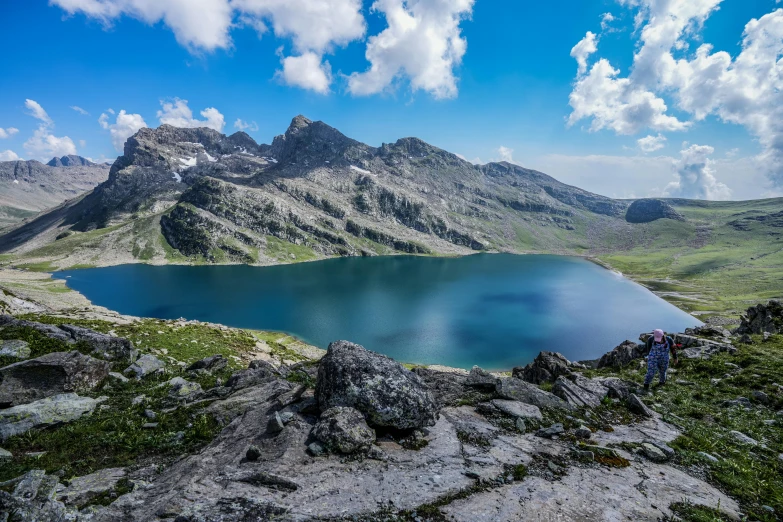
(55, 254), (700, 369)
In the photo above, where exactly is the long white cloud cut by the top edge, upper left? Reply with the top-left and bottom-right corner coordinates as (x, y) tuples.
(50, 0), (233, 51)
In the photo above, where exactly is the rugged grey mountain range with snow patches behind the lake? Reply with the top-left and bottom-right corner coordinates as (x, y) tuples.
(0, 116), (783, 309)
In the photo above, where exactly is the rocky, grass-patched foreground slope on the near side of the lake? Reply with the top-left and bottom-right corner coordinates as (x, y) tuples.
(0, 301), (783, 522)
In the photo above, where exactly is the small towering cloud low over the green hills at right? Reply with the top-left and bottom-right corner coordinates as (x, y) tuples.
(664, 145), (731, 200)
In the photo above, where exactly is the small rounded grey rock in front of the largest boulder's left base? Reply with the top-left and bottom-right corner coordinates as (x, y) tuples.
(313, 406), (375, 454)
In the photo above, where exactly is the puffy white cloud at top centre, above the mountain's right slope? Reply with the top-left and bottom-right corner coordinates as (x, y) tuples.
(348, 0), (474, 99)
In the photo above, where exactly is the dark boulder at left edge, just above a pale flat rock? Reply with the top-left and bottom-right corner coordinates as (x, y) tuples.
(0, 351), (109, 407)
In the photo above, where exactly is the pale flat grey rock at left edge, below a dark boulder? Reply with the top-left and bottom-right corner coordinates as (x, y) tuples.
(0, 393), (98, 440)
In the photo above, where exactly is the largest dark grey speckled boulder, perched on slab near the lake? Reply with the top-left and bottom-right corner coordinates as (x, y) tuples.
(315, 341), (438, 429)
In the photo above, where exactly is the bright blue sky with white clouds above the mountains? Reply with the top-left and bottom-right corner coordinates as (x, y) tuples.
(0, 0), (783, 200)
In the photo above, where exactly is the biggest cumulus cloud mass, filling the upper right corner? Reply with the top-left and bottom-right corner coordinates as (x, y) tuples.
(568, 0), (783, 186)
